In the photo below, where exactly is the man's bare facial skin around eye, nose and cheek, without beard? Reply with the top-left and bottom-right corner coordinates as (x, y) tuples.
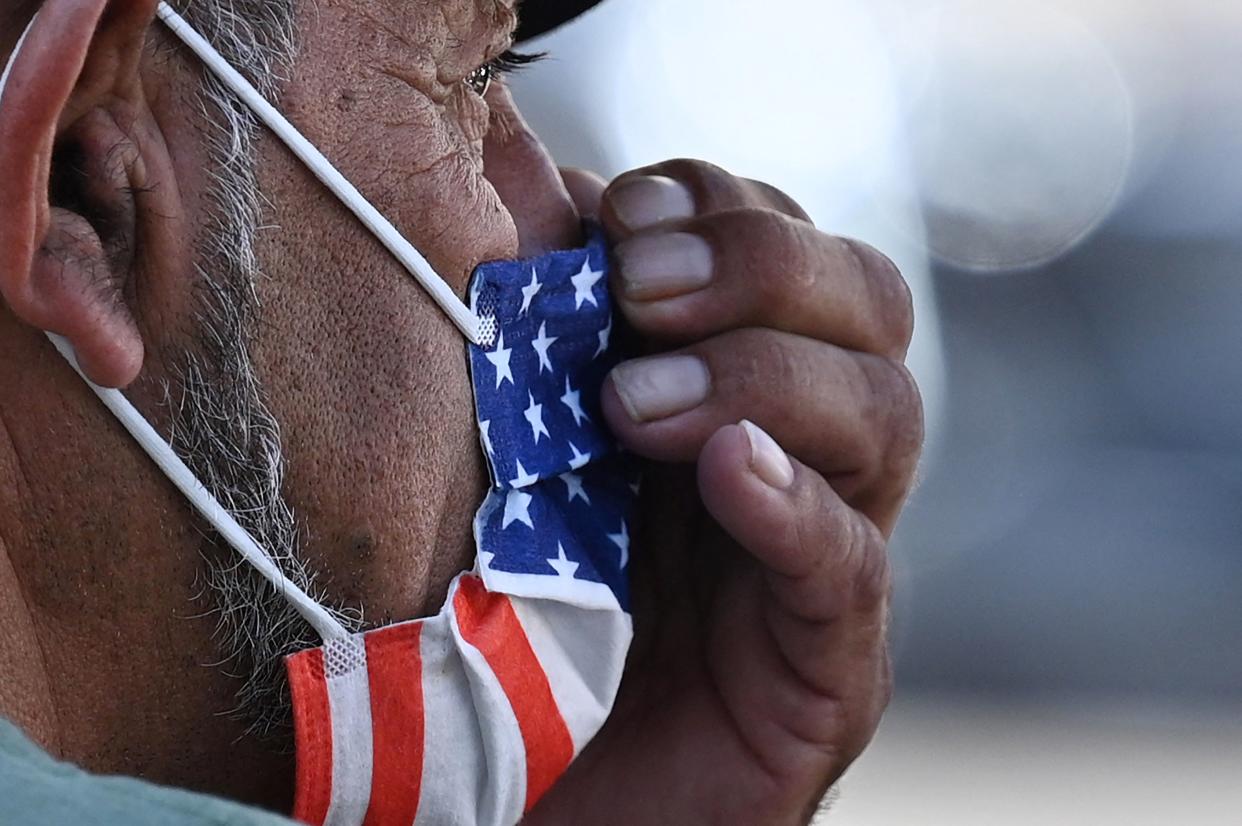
(181, 0), (576, 622)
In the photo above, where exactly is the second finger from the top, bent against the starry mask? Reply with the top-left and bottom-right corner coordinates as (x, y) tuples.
(616, 209), (914, 359)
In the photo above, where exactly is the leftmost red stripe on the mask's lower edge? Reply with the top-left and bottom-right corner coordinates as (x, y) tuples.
(284, 648), (332, 826)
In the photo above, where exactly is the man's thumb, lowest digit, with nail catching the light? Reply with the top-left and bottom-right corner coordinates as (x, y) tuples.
(698, 422), (891, 769)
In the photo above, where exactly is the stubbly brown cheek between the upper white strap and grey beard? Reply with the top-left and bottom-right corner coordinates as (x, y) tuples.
(245, 136), (489, 619)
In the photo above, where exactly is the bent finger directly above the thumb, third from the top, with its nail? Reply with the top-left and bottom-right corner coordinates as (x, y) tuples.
(602, 329), (923, 532)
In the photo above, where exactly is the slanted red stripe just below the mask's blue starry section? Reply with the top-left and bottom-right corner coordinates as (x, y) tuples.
(453, 576), (574, 811)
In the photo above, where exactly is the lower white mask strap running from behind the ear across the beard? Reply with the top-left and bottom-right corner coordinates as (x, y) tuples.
(0, 12), (349, 642)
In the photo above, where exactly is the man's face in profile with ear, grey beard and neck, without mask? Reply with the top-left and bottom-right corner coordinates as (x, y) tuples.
(0, 0), (581, 806)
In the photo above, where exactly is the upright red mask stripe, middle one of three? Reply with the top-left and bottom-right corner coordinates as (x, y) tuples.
(364, 622), (425, 826)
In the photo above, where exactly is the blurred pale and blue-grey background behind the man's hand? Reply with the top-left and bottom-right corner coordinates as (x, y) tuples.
(513, 0), (1242, 826)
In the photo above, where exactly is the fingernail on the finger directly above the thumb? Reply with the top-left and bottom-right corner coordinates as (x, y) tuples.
(612, 355), (712, 425)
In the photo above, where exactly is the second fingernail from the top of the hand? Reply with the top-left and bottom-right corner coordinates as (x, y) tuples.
(616, 232), (712, 301)
